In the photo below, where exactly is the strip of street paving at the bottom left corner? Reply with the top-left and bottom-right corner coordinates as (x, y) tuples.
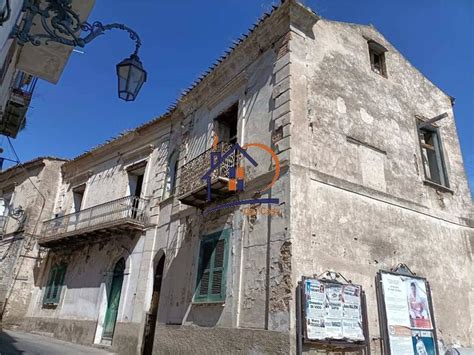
(0, 329), (113, 355)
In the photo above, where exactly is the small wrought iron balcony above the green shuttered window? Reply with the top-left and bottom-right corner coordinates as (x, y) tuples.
(178, 143), (238, 208)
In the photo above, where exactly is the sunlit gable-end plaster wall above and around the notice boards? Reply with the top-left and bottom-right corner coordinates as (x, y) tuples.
(290, 11), (474, 354)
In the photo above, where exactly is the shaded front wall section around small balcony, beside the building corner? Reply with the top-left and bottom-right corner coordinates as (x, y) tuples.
(150, 4), (293, 353)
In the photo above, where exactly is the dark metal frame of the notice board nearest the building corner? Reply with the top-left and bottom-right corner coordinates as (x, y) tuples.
(296, 276), (370, 354)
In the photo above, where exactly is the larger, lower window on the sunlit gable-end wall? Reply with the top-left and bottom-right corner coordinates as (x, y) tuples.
(418, 126), (449, 187)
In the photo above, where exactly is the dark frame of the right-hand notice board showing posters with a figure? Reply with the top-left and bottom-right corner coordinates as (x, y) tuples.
(375, 264), (441, 355)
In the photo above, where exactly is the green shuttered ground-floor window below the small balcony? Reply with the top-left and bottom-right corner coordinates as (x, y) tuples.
(194, 229), (231, 303)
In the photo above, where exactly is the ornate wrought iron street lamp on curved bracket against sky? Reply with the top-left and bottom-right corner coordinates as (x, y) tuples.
(10, 0), (146, 101)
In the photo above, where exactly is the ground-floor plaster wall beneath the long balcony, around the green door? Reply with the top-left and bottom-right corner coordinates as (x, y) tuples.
(25, 235), (145, 344)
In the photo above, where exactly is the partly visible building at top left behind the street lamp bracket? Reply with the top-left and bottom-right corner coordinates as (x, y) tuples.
(0, 0), (95, 138)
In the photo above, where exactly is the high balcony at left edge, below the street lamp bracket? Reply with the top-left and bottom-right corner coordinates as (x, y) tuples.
(0, 72), (38, 138)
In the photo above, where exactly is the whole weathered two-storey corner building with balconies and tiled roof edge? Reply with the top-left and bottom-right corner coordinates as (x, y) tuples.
(1, 0), (474, 355)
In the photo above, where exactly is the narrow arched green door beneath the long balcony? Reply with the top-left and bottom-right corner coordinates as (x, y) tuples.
(102, 258), (125, 343)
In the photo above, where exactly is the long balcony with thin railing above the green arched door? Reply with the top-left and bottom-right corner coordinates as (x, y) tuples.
(39, 196), (148, 247)
